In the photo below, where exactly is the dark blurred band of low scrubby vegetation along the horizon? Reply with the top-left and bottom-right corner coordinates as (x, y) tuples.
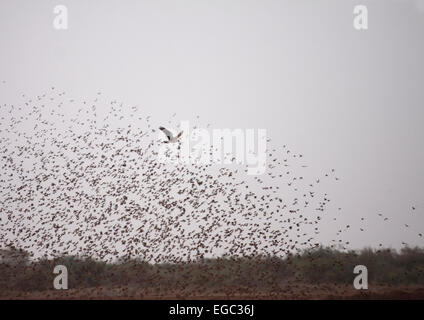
(0, 247), (424, 295)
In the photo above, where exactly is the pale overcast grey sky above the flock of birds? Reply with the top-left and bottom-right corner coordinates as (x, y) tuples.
(0, 0), (424, 248)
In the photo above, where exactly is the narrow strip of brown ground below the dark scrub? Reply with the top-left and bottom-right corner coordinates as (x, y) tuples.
(0, 284), (424, 300)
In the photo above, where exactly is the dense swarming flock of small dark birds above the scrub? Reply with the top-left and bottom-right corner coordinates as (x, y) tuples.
(0, 83), (422, 298)
